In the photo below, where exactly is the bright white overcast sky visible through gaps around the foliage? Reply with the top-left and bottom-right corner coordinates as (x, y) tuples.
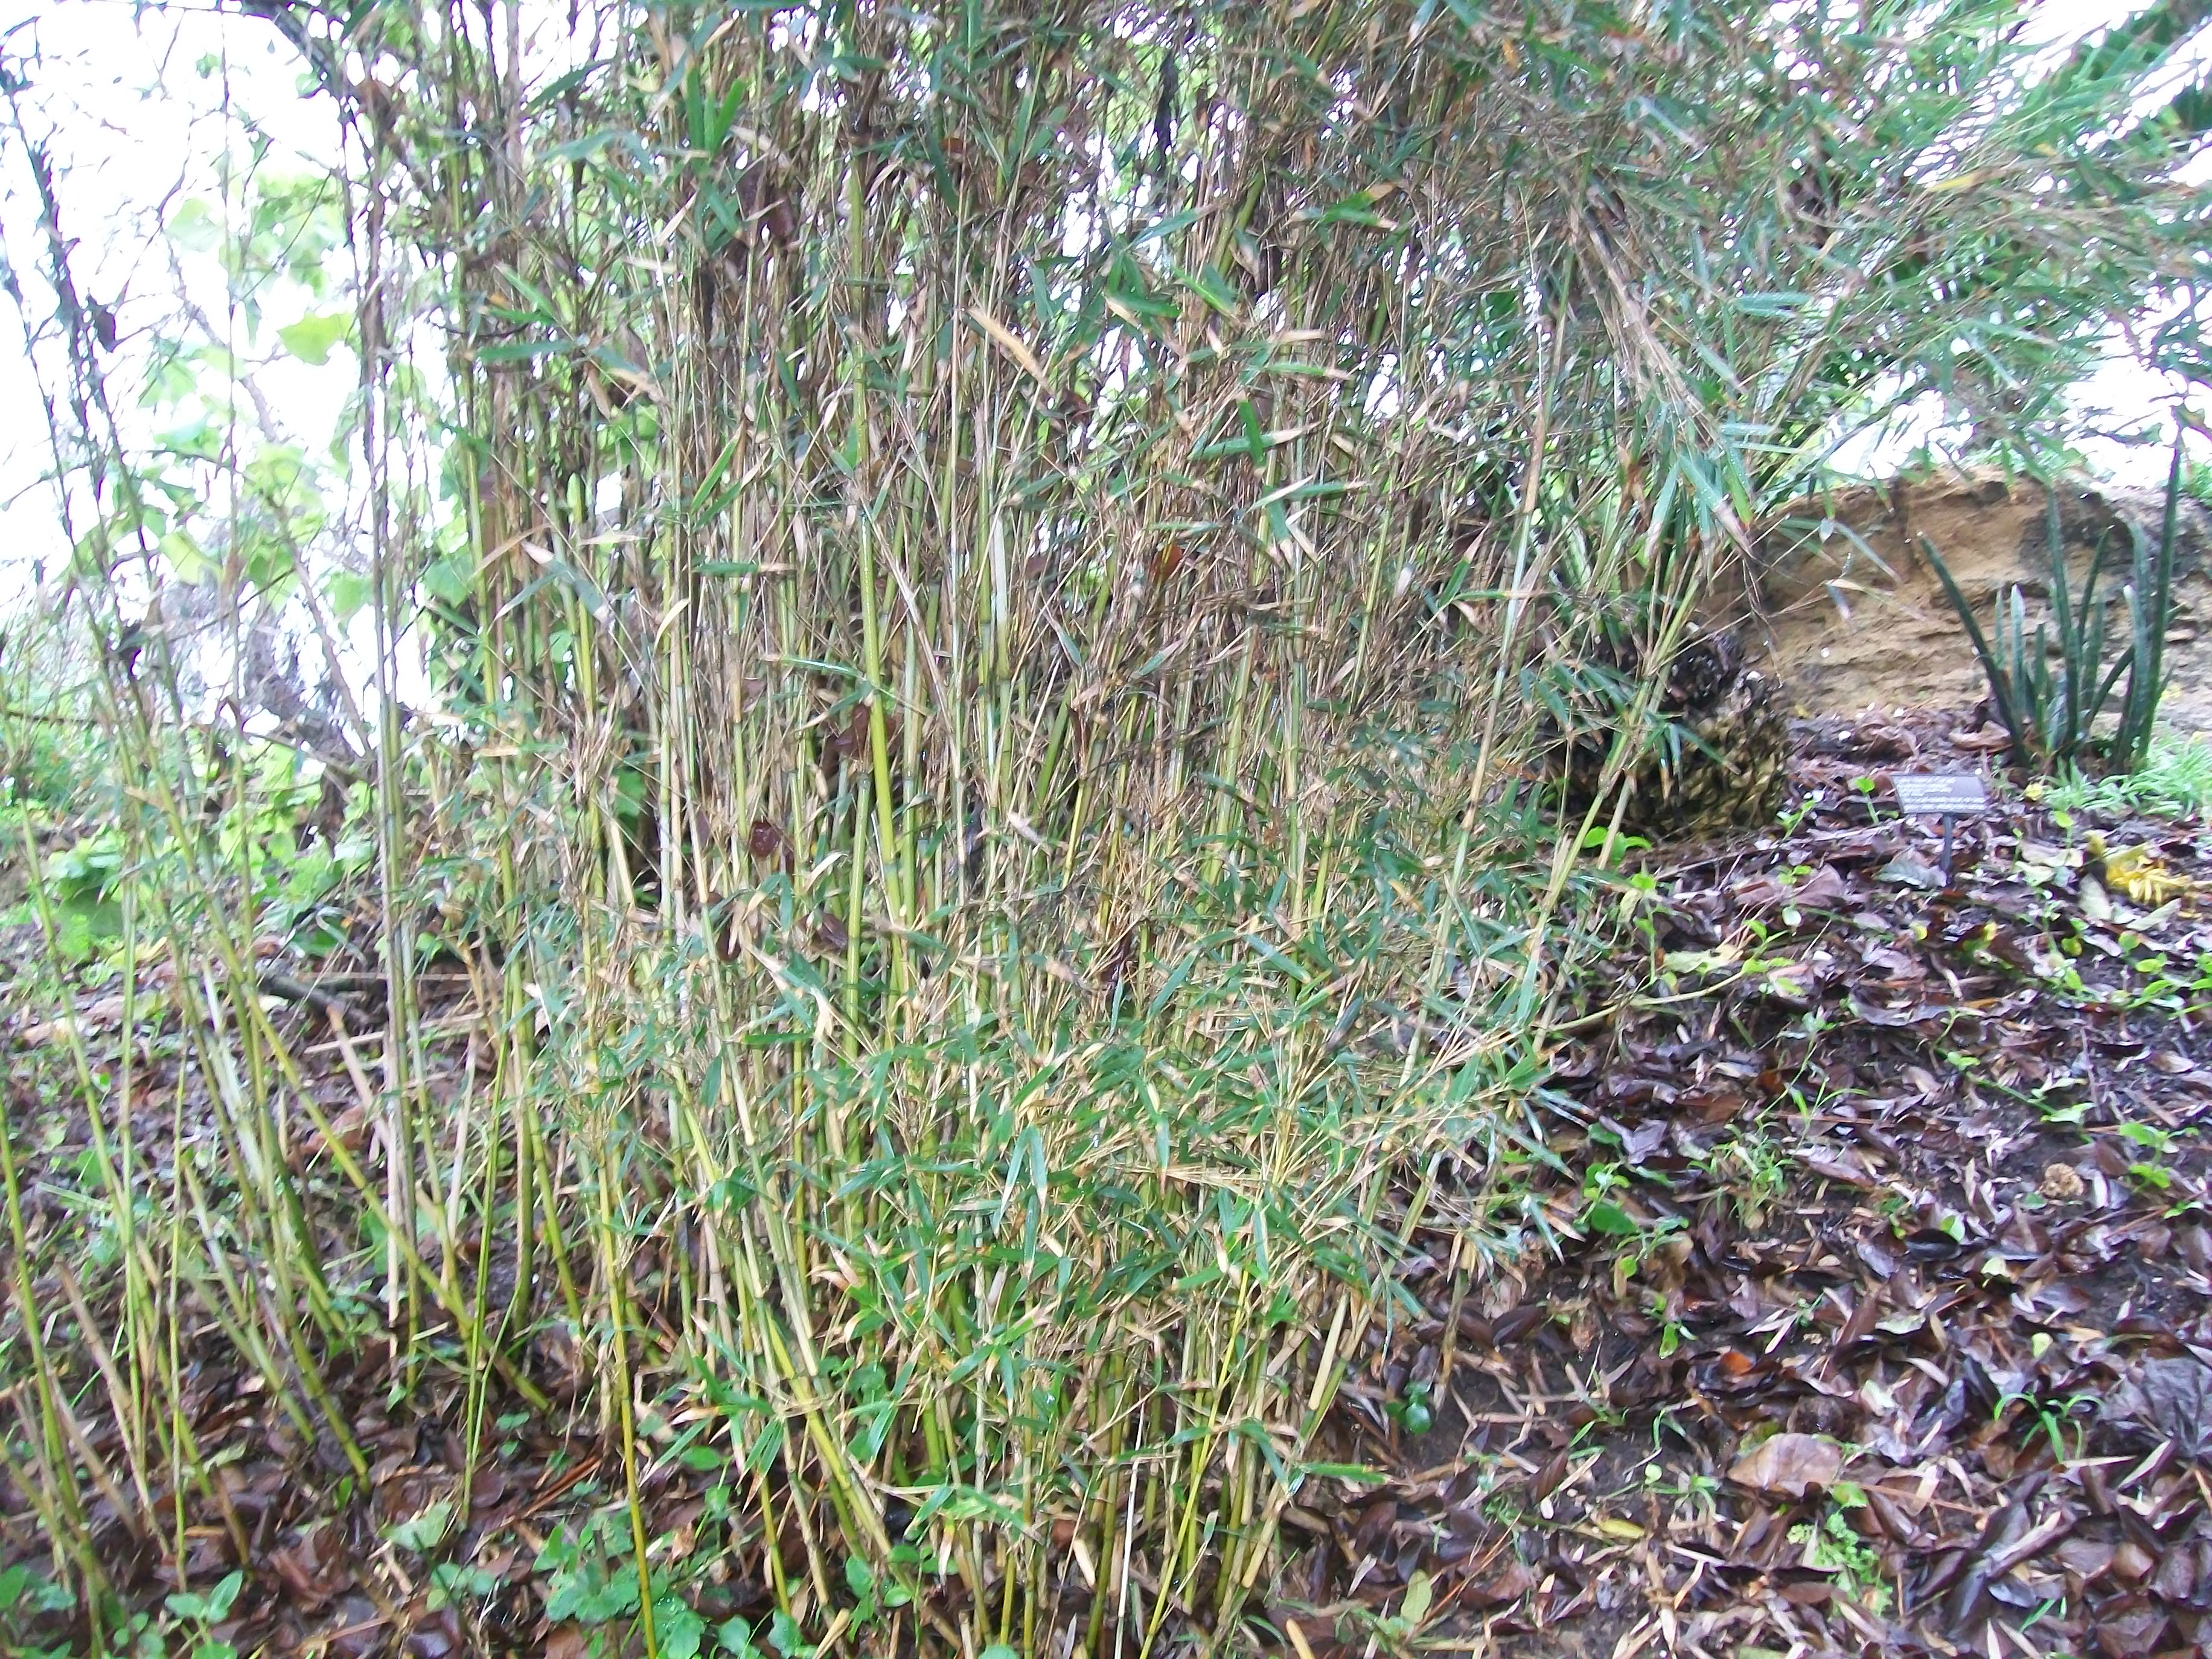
(0, 0), (2179, 619)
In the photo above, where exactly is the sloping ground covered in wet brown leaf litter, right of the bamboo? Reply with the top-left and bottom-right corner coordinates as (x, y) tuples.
(1279, 717), (2212, 1659)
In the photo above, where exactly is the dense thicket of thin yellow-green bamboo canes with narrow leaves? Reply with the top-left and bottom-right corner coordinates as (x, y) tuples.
(9, 0), (2194, 1655)
